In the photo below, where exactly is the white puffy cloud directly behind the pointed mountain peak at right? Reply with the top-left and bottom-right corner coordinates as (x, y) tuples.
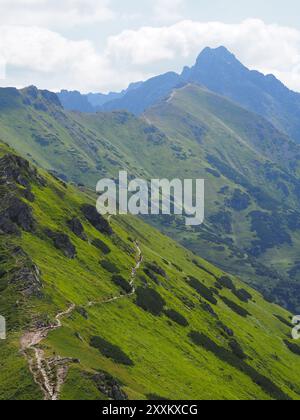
(106, 19), (300, 90)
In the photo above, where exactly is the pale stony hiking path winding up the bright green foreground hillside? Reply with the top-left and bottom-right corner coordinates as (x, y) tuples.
(21, 241), (143, 401)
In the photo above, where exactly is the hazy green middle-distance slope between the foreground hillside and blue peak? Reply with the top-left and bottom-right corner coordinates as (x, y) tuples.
(0, 85), (300, 311)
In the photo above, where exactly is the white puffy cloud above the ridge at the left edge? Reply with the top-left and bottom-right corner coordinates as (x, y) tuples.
(0, 26), (147, 91)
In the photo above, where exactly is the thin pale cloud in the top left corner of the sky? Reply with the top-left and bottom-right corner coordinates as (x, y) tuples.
(0, 0), (114, 28)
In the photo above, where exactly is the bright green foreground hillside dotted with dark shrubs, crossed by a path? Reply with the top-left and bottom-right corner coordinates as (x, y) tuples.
(0, 145), (300, 400)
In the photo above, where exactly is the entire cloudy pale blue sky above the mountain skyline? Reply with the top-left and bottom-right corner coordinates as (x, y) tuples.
(0, 0), (300, 93)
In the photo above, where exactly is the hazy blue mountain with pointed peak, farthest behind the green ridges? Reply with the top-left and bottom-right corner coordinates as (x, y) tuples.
(56, 46), (300, 143)
